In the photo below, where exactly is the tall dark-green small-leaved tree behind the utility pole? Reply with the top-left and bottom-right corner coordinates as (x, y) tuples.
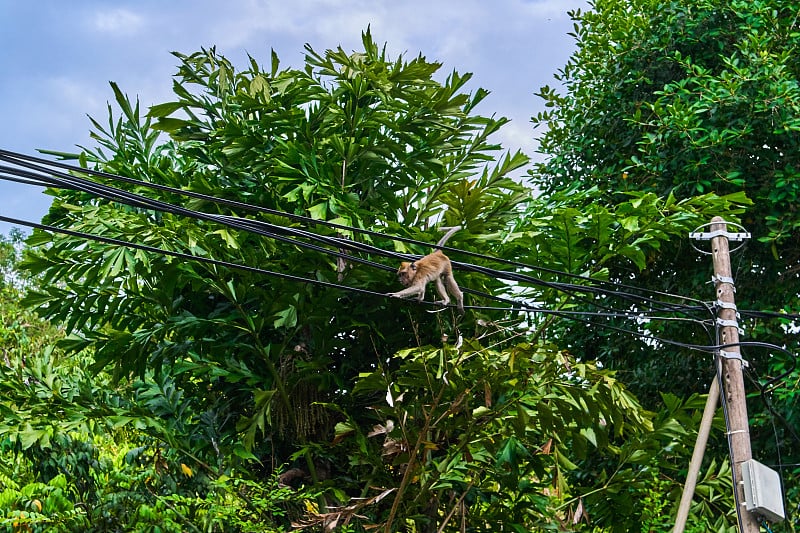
(533, 0), (800, 524)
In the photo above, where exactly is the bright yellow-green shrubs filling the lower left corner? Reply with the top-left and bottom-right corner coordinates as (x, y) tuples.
(0, 232), (322, 532)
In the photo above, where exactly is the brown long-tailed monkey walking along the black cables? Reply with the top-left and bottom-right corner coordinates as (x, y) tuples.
(388, 226), (464, 315)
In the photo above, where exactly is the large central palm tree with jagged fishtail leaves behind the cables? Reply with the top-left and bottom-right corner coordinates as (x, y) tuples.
(29, 29), (525, 462)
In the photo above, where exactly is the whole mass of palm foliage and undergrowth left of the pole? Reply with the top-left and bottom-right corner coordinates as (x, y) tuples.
(0, 13), (788, 532)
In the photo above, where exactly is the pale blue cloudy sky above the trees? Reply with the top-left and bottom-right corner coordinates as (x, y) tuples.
(0, 0), (587, 233)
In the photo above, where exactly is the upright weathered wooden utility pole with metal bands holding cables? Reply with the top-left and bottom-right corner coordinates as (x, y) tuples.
(710, 217), (760, 533)
